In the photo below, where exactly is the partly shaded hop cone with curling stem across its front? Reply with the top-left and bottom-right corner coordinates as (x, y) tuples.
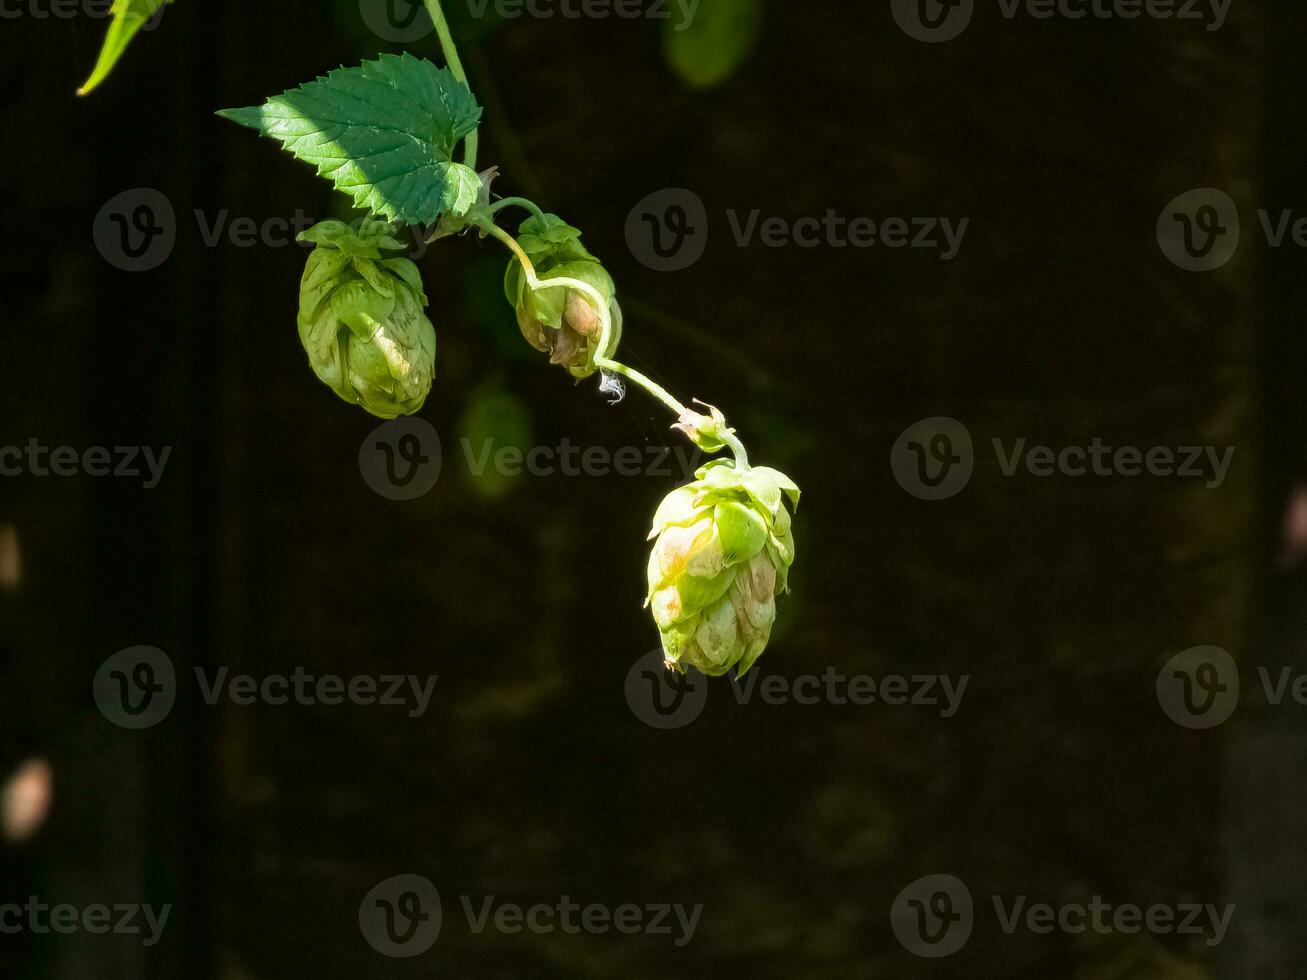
(503, 214), (622, 379)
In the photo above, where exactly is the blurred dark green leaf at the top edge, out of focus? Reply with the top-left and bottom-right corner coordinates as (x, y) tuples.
(663, 0), (762, 89)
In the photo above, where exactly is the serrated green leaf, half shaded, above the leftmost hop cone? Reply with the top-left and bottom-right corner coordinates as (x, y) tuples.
(218, 52), (481, 225)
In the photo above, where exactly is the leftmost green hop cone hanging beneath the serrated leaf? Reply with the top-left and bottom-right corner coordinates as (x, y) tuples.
(299, 221), (435, 418)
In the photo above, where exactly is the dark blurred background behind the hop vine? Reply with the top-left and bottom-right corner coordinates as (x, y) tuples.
(0, 0), (1307, 980)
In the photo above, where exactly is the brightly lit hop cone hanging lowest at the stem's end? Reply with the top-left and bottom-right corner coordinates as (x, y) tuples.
(646, 460), (799, 677)
